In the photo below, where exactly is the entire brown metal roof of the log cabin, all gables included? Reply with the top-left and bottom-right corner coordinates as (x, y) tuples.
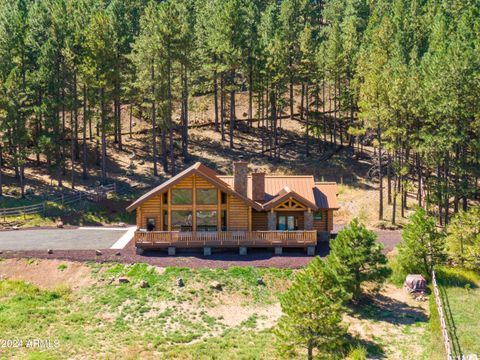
(127, 162), (339, 211)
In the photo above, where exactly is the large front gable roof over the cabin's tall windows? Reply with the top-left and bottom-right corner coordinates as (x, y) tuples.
(127, 162), (262, 211)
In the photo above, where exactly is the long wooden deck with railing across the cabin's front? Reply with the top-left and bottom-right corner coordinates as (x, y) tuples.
(134, 230), (317, 249)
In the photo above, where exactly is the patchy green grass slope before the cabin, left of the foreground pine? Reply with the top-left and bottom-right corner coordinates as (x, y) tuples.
(0, 264), (292, 358)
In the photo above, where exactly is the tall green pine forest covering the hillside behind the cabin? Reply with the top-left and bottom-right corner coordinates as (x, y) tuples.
(0, 0), (480, 223)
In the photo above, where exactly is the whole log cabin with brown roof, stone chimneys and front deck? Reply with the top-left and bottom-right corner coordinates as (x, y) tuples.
(127, 161), (338, 255)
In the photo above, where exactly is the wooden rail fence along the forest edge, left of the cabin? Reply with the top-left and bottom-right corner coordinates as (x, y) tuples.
(0, 183), (117, 221)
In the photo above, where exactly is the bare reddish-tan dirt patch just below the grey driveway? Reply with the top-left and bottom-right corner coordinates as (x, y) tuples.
(0, 259), (95, 289)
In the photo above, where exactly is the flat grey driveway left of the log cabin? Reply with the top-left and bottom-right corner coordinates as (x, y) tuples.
(0, 227), (128, 251)
